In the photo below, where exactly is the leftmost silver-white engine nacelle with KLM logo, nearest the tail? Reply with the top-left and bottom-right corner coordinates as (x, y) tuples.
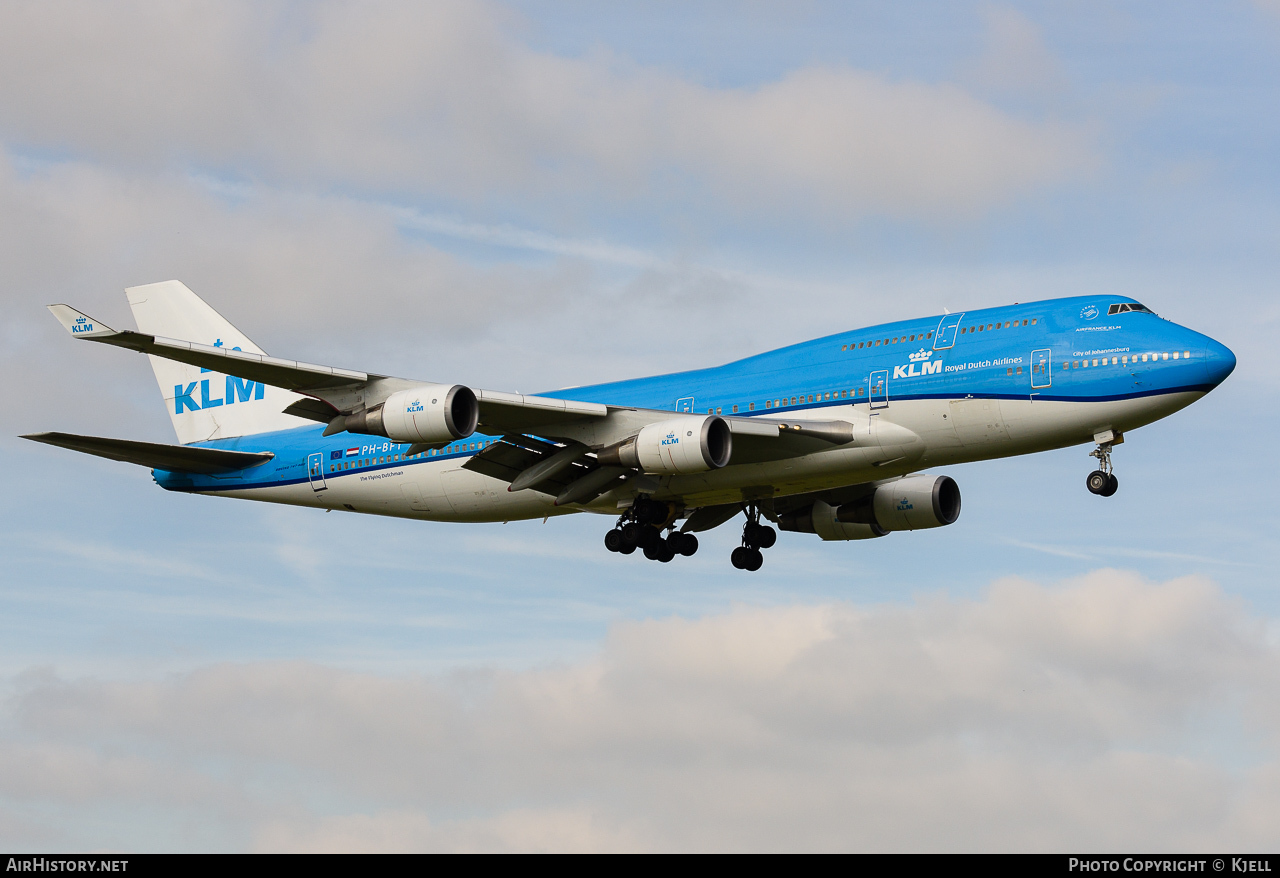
(346, 384), (480, 445)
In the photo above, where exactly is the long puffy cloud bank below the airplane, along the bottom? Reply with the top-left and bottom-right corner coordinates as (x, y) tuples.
(0, 571), (1280, 851)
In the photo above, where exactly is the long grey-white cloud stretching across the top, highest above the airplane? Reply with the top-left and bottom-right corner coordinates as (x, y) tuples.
(0, 0), (1097, 221)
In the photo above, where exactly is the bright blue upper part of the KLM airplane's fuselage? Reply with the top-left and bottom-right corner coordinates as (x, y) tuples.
(155, 297), (1235, 518)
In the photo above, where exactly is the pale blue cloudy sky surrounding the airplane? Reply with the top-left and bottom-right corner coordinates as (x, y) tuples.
(0, 0), (1280, 851)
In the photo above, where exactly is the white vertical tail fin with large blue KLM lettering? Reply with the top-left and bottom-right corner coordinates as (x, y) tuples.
(124, 280), (310, 445)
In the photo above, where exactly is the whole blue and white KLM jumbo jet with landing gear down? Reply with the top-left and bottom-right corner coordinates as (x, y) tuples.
(23, 280), (1235, 571)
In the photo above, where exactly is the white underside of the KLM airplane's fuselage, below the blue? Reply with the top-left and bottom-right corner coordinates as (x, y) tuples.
(201, 392), (1203, 522)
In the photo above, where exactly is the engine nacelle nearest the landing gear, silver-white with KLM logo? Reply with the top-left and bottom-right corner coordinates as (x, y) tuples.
(596, 415), (733, 475)
